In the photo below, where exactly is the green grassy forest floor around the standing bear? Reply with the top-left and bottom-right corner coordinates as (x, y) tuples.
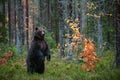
(0, 48), (120, 80)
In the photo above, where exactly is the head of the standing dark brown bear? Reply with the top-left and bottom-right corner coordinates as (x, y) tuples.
(34, 28), (45, 40)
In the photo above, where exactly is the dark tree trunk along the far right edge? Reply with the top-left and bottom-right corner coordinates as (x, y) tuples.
(114, 0), (120, 67)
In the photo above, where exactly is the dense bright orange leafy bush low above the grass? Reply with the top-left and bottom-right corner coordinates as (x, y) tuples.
(79, 39), (99, 71)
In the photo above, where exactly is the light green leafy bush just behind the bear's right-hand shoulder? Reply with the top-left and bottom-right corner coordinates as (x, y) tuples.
(45, 32), (56, 48)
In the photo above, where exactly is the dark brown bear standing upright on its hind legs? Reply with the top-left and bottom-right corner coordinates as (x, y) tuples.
(27, 28), (50, 74)
